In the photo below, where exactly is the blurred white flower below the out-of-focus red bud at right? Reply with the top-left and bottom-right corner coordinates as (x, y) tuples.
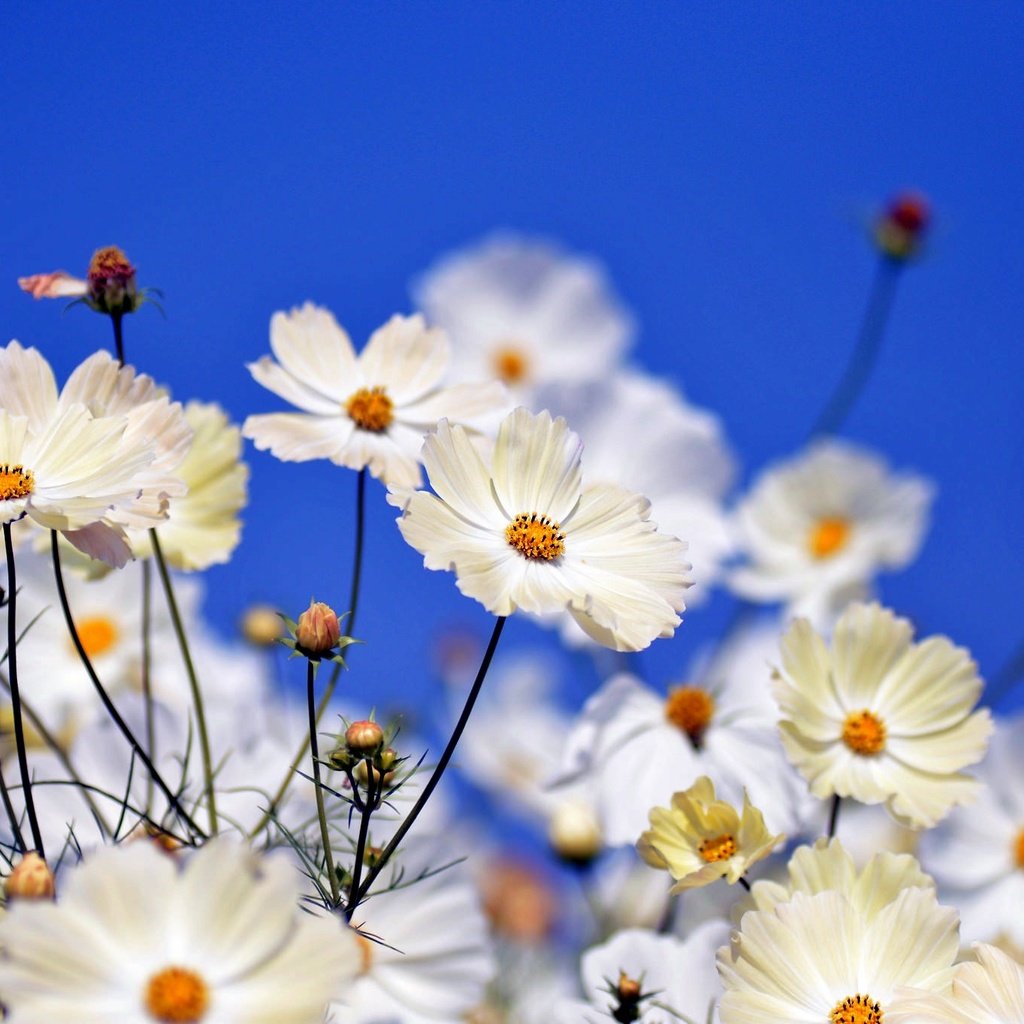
(729, 440), (932, 623)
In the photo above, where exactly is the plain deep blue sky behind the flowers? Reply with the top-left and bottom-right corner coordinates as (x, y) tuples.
(0, 2), (1024, 712)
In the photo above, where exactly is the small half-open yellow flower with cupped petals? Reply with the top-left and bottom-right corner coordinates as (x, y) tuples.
(637, 775), (785, 893)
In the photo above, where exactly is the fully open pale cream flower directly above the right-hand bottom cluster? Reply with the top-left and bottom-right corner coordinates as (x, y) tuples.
(773, 604), (992, 828)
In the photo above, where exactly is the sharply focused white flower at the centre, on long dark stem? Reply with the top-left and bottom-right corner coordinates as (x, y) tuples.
(398, 409), (689, 650)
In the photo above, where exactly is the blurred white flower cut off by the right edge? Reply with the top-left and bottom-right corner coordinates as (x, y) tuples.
(921, 718), (1024, 947)
